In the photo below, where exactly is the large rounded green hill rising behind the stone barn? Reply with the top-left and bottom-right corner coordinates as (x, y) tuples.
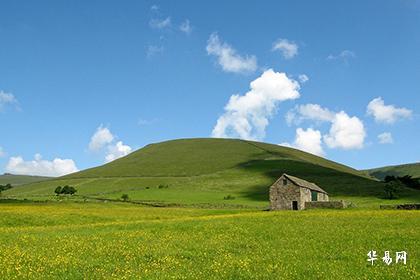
(4, 138), (420, 207)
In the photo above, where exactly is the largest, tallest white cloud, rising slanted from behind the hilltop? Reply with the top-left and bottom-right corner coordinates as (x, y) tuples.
(212, 69), (300, 140)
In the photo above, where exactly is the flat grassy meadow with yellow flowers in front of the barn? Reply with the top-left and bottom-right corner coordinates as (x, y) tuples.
(0, 203), (420, 279)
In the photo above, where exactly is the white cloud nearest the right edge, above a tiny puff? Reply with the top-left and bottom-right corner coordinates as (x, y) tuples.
(367, 97), (412, 124)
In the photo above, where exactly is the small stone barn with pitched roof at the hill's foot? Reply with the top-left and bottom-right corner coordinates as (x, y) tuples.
(270, 174), (328, 210)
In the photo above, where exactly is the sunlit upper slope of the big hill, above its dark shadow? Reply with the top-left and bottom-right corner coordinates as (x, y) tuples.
(66, 138), (362, 178)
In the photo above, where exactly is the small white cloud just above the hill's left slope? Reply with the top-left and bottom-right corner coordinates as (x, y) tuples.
(89, 125), (132, 162)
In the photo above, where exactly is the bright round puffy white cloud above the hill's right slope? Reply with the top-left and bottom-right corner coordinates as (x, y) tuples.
(324, 111), (366, 150)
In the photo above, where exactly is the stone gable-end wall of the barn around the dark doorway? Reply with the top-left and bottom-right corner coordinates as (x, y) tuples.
(270, 176), (302, 210)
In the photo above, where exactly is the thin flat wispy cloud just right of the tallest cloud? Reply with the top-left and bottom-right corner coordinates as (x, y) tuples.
(286, 104), (335, 125)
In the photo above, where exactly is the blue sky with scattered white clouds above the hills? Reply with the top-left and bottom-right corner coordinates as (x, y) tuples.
(0, 0), (420, 175)
